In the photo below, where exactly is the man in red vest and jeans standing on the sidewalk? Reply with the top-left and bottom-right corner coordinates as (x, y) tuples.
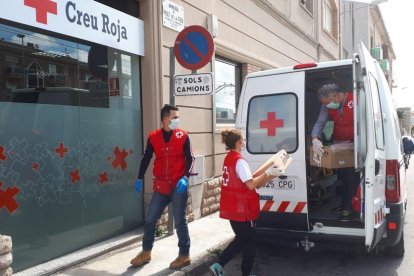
(131, 105), (194, 269)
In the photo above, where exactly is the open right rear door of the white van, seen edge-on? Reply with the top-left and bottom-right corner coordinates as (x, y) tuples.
(353, 43), (386, 251)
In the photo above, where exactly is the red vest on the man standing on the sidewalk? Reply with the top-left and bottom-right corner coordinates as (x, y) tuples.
(149, 129), (188, 195)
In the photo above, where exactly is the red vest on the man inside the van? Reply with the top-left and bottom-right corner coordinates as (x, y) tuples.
(328, 92), (354, 141)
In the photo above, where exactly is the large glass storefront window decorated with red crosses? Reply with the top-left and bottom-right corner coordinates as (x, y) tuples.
(0, 24), (143, 271)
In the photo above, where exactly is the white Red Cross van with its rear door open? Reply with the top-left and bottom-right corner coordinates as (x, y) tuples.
(236, 45), (407, 256)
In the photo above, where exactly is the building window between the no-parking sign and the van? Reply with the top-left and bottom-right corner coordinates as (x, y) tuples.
(215, 59), (240, 123)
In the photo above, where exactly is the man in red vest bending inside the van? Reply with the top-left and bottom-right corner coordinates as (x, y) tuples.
(311, 83), (359, 221)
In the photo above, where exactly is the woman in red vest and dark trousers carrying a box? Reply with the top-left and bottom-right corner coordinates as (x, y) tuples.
(210, 130), (284, 276)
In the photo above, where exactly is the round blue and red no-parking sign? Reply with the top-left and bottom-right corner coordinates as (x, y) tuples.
(174, 25), (214, 70)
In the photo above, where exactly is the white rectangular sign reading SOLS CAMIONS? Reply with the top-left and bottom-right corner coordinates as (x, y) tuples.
(174, 73), (214, 96)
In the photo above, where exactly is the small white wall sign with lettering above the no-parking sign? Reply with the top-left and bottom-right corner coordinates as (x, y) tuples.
(162, 0), (184, 32)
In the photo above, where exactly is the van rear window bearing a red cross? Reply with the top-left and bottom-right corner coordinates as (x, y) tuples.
(246, 93), (298, 153)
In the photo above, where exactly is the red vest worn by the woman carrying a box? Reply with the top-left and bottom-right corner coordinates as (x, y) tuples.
(220, 151), (260, 221)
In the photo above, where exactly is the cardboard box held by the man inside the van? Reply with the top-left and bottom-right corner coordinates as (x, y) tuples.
(309, 143), (354, 169)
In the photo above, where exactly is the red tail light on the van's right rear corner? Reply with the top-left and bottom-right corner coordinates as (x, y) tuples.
(385, 160), (401, 203)
